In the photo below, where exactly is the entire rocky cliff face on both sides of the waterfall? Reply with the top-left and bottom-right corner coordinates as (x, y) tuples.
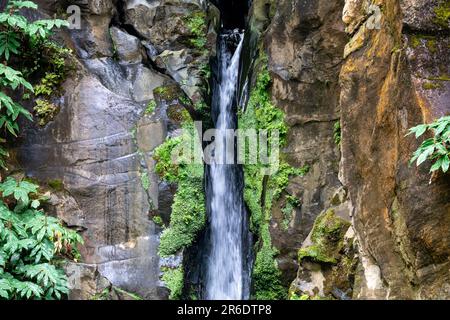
(16, 0), (450, 299)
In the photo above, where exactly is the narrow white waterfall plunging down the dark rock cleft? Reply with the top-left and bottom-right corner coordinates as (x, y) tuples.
(206, 34), (246, 300)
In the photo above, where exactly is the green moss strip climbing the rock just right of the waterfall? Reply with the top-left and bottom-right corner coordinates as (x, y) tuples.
(238, 56), (309, 300)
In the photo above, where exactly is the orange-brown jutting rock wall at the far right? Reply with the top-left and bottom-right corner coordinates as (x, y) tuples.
(340, 1), (450, 299)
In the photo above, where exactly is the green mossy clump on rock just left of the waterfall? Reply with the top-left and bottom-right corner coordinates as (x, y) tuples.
(154, 122), (206, 256)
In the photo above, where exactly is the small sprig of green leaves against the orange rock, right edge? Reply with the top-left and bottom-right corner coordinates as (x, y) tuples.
(408, 116), (450, 173)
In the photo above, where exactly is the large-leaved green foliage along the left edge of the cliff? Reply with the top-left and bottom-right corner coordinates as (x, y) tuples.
(0, 1), (83, 299)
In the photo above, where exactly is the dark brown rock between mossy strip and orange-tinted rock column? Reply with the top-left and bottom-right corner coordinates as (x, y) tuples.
(265, 1), (347, 283)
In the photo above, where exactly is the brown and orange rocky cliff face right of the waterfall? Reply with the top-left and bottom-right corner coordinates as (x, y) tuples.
(255, 0), (450, 299)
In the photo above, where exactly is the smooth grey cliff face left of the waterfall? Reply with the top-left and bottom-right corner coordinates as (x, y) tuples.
(17, 1), (219, 299)
